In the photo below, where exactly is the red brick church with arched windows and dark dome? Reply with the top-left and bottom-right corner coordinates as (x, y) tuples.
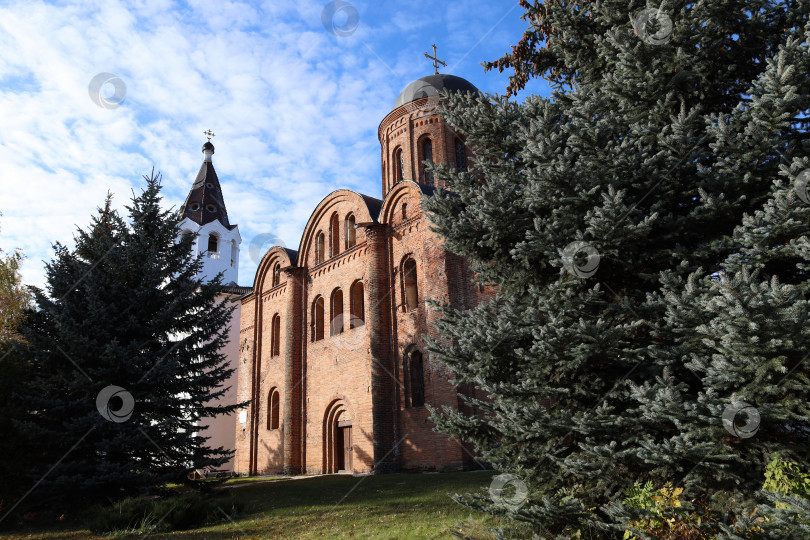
(234, 68), (491, 474)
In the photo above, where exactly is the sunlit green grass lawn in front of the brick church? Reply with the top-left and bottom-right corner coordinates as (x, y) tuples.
(4, 472), (504, 539)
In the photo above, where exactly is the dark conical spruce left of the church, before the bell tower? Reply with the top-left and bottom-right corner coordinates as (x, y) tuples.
(20, 175), (238, 507)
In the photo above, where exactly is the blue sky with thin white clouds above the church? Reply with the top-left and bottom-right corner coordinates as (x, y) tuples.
(0, 0), (548, 285)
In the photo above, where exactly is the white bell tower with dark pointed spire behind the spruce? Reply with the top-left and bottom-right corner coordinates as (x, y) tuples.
(180, 135), (242, 286)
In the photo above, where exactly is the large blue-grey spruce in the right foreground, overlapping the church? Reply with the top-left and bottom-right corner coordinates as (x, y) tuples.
(425, 0), (810, 538)
